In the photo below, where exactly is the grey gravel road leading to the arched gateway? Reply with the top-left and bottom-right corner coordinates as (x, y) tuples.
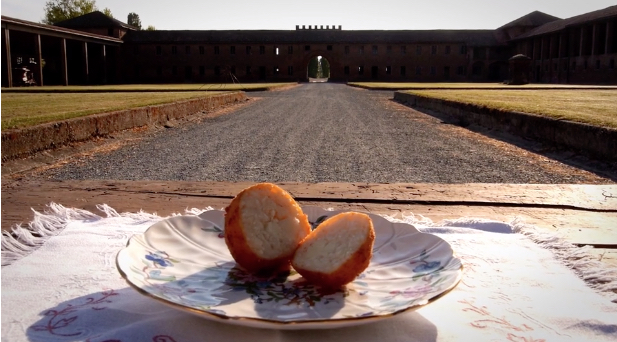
(47, 83), (611, 183)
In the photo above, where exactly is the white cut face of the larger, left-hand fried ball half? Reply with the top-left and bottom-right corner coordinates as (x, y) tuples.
(240, 190), (306, 259)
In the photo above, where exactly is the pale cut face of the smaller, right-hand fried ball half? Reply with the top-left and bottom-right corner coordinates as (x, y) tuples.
(294, 215), (370, 273)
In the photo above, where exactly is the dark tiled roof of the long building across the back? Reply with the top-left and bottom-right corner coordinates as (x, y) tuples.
(124, 29), (500, 46)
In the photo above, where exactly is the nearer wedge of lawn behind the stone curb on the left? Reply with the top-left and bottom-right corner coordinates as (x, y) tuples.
(2, 91), (223, 131)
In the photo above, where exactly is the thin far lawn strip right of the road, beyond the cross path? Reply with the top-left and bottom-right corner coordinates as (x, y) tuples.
(347, 82), (617, 90)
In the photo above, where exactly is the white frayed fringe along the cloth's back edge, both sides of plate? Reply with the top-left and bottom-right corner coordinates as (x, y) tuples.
(2, 203), (617, 303)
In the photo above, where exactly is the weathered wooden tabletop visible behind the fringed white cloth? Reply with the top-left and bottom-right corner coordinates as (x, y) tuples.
(2, 180), (617, 267)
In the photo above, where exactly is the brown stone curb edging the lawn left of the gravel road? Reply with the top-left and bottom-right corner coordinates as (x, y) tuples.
(2, 91), (247, 161)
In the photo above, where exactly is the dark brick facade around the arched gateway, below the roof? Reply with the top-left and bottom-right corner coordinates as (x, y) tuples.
(123, 42), (511, 83)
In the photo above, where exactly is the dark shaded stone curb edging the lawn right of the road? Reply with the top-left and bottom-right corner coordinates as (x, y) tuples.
(394, 91), (617, 160)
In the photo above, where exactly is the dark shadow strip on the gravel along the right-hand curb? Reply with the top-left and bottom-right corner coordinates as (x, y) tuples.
(390, 99), (617, 182)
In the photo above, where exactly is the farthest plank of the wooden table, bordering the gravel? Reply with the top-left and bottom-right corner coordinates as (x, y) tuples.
(9, 180), (617, 211)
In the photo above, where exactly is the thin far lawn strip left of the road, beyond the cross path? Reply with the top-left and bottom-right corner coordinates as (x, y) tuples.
(2, 83), (297, 93)
